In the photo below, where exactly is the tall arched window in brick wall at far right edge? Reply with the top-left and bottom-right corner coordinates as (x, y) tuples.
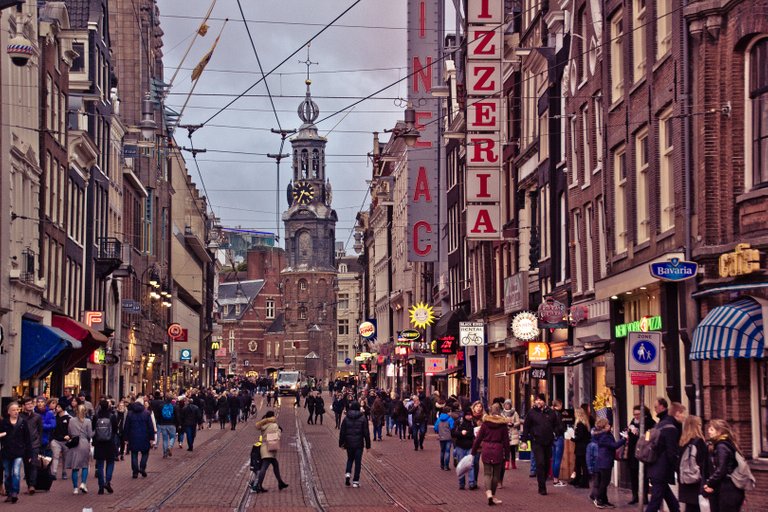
(746, 38), (768, 188)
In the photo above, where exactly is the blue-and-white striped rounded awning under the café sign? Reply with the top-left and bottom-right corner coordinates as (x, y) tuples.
(691, 298), (765, 360)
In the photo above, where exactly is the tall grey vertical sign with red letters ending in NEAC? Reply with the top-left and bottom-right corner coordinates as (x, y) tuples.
(408, 0), (442, 261)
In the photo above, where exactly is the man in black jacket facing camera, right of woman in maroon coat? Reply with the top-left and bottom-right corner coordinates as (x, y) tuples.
(522, 393), (562, 496)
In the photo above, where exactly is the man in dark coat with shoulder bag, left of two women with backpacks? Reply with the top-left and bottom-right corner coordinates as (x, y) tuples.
(645, 398), (685, 512)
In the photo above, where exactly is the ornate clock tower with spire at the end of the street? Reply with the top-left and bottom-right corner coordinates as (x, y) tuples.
(281, 74), (338, 381)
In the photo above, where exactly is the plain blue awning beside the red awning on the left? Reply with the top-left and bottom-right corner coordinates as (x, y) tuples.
(21, 320), (82, 380)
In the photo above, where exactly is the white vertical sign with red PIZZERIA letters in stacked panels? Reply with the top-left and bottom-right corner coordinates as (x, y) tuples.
(465, 0), (504, 240)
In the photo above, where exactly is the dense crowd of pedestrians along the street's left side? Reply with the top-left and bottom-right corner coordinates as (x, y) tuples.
(0, 380), (256, 503)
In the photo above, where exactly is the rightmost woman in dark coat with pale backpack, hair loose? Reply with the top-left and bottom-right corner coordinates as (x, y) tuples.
(703, 419), (754, 512)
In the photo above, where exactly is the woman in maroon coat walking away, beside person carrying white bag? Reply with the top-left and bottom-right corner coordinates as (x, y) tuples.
(472, 403), (509, 505)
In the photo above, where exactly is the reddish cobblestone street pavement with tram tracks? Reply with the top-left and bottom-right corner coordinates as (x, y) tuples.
(6, 398), (635, 512)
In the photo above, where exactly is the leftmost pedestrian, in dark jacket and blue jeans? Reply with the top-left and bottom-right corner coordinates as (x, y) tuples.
(0, 402), (32, 503)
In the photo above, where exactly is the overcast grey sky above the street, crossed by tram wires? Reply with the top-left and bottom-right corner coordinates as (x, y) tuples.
(158, 0), (406, 254)
